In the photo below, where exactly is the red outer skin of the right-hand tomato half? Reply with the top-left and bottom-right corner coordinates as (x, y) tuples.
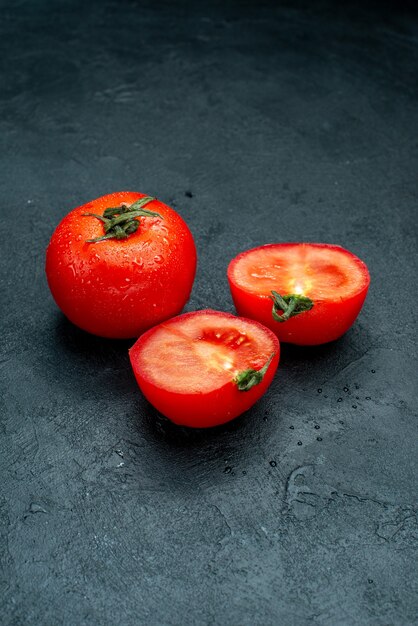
(227, 244), (370, 346)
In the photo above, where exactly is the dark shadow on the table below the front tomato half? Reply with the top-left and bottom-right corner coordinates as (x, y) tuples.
(132, 398), (278, 488)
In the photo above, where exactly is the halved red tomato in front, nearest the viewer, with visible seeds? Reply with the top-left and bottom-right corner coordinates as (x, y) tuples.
(130, 310), (280, 428)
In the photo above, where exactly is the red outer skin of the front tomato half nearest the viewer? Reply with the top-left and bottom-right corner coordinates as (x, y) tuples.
(129, 310), (280, 428)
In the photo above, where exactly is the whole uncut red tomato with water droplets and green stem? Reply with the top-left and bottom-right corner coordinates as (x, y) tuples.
(46, 191), (196, 338)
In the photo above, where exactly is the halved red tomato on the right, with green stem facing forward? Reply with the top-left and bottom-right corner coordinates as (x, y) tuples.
(228, 243), (370, 346)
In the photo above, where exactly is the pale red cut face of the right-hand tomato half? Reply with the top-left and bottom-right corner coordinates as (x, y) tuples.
(230, 243), (369, 302)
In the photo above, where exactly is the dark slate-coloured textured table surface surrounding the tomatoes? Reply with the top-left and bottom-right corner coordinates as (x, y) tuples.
(0, 0), (418, 626)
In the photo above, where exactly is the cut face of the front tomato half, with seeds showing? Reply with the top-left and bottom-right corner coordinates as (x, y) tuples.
(134, 311), (278, 394)
